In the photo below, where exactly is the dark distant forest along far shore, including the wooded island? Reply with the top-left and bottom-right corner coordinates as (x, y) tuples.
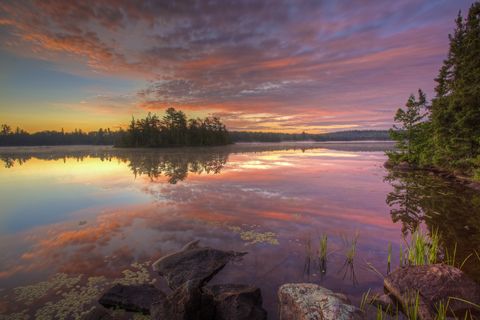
(0, 112), (390, 147)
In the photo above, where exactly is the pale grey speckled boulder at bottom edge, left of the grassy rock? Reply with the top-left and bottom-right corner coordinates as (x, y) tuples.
(278, 283), (362, 320)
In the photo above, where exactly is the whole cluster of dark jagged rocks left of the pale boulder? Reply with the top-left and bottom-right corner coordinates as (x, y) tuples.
(96, 241), (267, 320)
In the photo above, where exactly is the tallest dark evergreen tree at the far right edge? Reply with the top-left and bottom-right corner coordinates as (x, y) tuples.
(432, 2), (480, 171)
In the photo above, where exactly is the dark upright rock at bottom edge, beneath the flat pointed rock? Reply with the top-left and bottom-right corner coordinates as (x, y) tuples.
(150, 280), (215, 320)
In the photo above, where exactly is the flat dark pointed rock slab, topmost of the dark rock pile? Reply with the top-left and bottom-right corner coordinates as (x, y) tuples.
(152, 241), (246, 290)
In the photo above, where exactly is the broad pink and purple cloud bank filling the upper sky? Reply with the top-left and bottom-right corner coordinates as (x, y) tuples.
(0, 0), (468, 129)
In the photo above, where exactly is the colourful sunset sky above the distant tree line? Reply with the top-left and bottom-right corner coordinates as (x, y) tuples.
(0, 0), (471, 133)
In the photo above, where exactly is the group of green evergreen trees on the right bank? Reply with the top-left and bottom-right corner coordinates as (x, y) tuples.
(388, 1), (480, 180)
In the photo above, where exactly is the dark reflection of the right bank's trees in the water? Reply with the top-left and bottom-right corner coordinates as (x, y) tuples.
(385, 170), (480, 279)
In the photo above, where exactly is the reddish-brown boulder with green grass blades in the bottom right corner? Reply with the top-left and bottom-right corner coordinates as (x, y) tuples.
(383, 264), (480, 320)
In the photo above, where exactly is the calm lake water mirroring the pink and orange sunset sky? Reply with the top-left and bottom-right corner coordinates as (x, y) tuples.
(0, 143), (480, 319)
